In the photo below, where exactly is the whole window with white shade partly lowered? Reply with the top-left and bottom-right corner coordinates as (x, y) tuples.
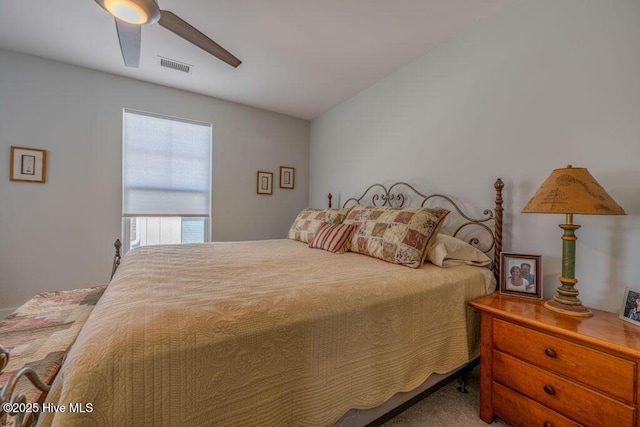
(122, 109), (211, 252)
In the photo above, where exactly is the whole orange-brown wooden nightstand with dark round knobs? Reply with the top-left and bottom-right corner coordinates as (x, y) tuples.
(469, 293), (640, 427)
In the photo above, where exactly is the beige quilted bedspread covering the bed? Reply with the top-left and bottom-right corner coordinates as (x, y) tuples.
(40, 240), (490, 427)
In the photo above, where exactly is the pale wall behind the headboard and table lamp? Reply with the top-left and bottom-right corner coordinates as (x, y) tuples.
(310, 0), (640, 312)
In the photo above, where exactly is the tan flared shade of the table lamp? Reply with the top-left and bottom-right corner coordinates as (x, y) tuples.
(522, 165), (626, 215)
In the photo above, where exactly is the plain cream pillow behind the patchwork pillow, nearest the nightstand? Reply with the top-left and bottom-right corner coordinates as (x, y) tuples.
(427, 233), (491, 267)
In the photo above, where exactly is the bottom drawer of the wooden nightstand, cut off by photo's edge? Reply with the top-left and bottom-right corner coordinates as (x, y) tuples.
(493, 383), (580, 427)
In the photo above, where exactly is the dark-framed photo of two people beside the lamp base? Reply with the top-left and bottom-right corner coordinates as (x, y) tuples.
(500, 253), (542, 299)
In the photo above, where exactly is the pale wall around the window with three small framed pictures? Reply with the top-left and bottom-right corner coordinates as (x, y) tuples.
(0, 50), (309, 314)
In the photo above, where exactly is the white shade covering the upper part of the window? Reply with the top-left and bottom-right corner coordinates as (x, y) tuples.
(122, 109), (211, 217)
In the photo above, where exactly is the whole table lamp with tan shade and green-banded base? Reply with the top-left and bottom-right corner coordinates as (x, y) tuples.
(522, 165), (626, 317)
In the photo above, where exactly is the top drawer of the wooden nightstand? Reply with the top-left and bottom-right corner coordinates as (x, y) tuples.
(493, 319), (636, 403)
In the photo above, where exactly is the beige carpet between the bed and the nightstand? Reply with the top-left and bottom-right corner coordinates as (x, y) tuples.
(383, 366), (509, 427)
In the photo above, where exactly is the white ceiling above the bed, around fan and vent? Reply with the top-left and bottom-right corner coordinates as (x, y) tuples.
(0, 0), (510, 119)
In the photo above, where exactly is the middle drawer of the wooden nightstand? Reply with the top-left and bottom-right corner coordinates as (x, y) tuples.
(493, 351), (636, 427)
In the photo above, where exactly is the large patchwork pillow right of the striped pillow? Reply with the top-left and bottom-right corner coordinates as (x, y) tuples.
(344, 206), (449, 268)
